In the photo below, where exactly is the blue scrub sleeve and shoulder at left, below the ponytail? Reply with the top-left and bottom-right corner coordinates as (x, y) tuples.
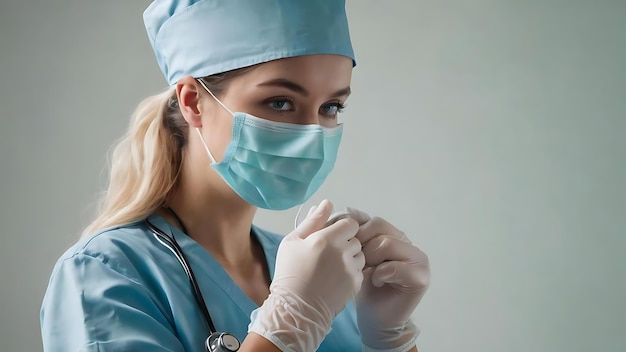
(40, 223), (182, 351)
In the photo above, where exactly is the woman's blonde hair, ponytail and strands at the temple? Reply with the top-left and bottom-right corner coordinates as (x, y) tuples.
(82, 66), (253, 236)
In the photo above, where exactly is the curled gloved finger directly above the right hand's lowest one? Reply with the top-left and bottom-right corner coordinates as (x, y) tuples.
(363, 235), (425, 266)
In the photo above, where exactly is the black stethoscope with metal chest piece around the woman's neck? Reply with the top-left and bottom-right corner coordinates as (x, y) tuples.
(144, 208), (241, 352)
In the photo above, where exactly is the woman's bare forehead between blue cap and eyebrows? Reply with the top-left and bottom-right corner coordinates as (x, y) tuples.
(227, 55), (352, 92)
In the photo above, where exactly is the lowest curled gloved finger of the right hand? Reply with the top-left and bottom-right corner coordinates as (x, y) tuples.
(371, 261), (430, 293)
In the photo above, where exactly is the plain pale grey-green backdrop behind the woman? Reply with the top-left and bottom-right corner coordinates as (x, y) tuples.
(0, 0), (626, 352)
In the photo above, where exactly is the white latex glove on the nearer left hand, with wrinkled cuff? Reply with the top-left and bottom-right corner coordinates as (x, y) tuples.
(248, 200), (365, 352)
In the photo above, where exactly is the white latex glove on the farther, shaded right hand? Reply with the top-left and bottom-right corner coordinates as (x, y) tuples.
(347, 208), (430, 352)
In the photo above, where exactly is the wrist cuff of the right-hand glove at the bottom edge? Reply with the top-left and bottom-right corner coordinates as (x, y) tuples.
(361, 320), (420, 352)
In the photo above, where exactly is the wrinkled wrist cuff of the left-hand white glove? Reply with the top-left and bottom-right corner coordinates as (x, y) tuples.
(248, 293), (333, 352)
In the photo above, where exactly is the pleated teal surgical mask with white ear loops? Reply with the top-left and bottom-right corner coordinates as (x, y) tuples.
(196, 80), (343, 210)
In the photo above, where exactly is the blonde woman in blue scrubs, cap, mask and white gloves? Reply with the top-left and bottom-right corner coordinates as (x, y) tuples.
(41, 0), (429, 351)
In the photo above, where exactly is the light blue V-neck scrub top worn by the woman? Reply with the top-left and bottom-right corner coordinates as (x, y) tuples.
(41, 214), (361, 352)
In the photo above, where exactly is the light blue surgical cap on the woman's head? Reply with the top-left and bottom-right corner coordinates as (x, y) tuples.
(143, 0), (356, 85)
